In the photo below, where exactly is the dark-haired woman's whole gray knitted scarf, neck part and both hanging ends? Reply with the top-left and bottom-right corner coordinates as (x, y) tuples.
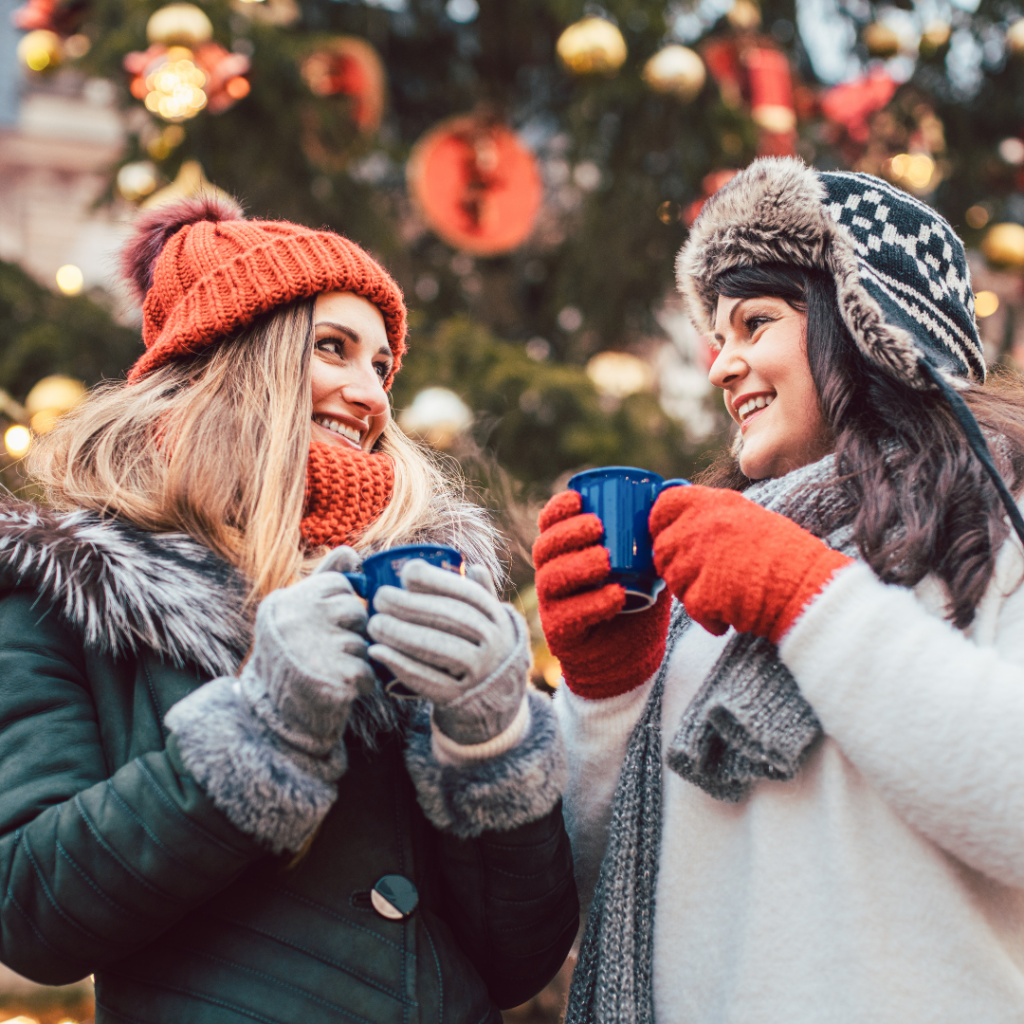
(565, 456), (857, 1024)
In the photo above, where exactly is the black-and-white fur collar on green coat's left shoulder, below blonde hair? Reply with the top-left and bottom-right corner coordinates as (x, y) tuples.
(0, 502), (252, 676)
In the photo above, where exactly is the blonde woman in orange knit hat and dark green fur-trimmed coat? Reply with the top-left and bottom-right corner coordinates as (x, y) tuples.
(0, 199), (577, 1024)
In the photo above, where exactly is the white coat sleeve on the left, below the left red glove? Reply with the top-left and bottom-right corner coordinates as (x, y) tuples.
(555, 677), (653, 911)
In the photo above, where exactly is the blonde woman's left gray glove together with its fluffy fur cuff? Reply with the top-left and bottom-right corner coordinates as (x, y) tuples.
(164, 548), (375, 853)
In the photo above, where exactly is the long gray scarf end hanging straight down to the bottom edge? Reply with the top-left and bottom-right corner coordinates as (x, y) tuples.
(565, 603), (689, 1024)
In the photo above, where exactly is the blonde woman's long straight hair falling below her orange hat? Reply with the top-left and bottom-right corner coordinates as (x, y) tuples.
(28, 300), (503, 601)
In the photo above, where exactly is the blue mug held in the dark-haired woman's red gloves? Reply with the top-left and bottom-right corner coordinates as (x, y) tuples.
(568, 466), (690, 613)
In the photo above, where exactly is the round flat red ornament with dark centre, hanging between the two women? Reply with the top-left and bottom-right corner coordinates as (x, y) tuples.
(408, 115), (544, 256)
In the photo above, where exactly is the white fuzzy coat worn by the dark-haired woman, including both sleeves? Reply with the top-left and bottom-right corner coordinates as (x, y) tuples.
(555, 540), (1024, 1024)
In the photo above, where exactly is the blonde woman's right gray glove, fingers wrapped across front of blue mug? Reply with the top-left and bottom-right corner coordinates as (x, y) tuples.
(367, 559), (529, 744)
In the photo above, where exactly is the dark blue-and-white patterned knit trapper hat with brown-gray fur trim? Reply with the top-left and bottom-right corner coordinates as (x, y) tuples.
(676, 158), (985, 389)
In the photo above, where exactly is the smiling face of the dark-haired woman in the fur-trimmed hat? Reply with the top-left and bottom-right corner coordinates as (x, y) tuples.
(708, 295), (831, 480)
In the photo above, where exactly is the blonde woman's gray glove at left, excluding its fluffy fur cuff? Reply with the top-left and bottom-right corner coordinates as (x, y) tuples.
(239, 547), (375, 757)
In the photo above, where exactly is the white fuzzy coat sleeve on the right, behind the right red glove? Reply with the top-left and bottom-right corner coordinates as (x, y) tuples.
(779, 559), (1024, 886)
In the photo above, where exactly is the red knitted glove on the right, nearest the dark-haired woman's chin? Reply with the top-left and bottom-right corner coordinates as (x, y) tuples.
(650, 486), (851, 643)
